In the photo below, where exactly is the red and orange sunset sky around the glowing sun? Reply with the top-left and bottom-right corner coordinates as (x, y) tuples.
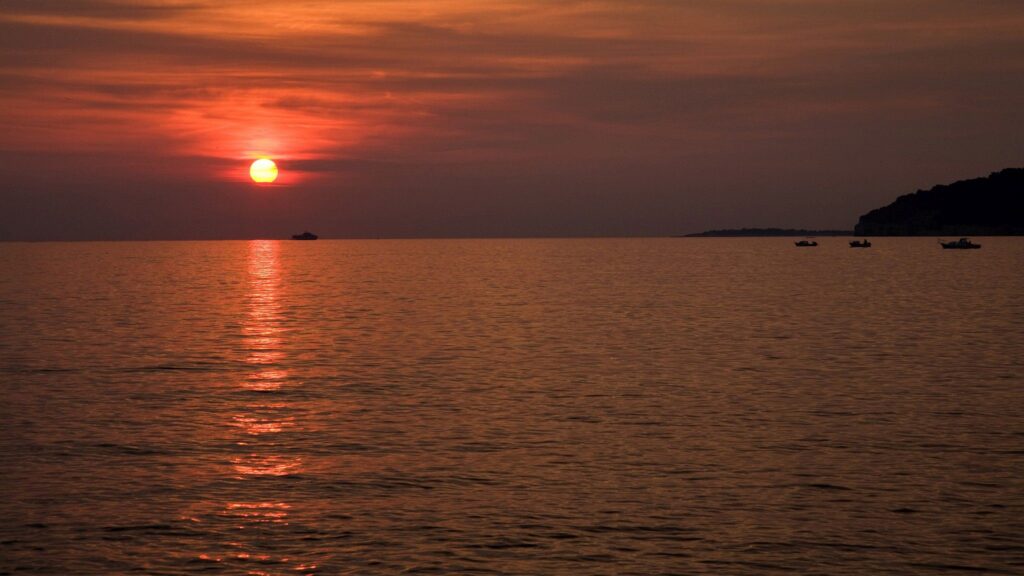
(0, 0), (1024, 240)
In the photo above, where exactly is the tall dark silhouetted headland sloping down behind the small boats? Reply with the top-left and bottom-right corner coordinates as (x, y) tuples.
(854, 168), (1024, 236)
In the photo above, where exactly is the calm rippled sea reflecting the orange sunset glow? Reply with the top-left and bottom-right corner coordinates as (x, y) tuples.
(0, 238), (1024, 575)
